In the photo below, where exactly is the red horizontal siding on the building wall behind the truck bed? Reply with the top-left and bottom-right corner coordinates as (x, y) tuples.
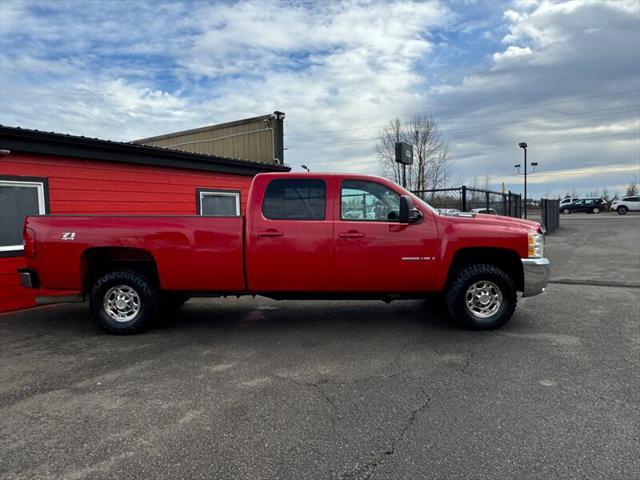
(0, 153), (253, 312)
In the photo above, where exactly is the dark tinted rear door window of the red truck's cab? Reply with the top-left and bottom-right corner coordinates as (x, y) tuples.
(262, 179), (327, 220)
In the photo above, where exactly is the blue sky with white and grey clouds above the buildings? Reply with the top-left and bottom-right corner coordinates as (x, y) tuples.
(0, 0), (640, 196)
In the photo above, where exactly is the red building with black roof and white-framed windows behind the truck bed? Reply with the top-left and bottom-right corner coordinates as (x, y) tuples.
(0, 126), (289, 312)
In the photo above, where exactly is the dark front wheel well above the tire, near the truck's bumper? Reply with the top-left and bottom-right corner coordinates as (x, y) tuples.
(447, 247), (524, 291)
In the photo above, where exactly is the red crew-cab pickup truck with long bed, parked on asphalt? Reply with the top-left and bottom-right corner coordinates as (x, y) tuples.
(19, 173), (549, 334)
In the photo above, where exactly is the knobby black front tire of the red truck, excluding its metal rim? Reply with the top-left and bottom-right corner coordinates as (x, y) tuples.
(444, 263), (518, 330)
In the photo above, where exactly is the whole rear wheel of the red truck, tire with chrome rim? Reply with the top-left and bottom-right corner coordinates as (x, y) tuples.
(89, 270), (160, 335)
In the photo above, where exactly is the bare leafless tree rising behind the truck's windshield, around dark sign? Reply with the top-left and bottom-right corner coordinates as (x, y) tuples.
(376, 115), (449, 190)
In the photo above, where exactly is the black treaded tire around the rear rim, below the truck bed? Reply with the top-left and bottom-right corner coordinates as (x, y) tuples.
(89, 270), (161, 335)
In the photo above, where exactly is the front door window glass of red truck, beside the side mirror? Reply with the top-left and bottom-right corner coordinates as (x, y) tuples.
(340, 180), (400, 222)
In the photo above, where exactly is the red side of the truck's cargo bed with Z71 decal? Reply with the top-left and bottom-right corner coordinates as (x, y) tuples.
(25, 215), (245, 292)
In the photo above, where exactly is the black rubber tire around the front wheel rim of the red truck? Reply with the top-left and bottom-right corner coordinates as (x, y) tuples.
(445, 264), (518, 330)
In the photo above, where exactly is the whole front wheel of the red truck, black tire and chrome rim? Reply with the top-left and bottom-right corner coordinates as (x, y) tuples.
(445, 264), (518, 330)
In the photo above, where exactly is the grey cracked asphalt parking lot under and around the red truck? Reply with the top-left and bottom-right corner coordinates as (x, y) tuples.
(0, 214), (640, 479)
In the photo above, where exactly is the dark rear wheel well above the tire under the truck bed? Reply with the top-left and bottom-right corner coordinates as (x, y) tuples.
(81, 247), (159, 291)
